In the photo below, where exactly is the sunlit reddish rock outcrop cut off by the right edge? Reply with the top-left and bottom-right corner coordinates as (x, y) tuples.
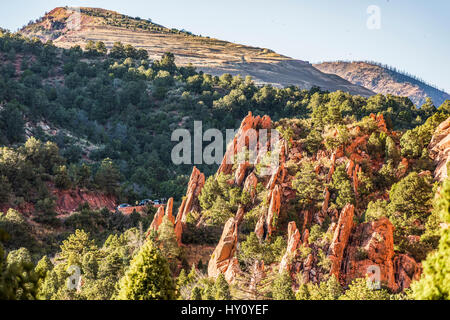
(428, 117), (450, 181)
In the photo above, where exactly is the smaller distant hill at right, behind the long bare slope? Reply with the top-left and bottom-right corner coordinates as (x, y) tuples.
(314, 61), (450, 106)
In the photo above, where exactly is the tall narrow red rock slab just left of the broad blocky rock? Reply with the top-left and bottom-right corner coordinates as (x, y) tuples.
(328, 204), (355, 279)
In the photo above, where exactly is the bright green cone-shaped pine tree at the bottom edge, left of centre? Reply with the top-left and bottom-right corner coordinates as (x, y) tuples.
(117, 241), (176, 300)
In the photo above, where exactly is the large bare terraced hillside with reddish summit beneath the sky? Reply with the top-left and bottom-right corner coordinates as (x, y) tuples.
(21, 8), (374, 97)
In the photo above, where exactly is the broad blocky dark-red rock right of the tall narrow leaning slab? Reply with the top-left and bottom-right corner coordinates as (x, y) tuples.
(342, 218), (398, 291)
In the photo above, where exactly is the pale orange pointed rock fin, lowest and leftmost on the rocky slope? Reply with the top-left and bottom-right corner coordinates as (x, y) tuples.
(208, 208), (243, 282)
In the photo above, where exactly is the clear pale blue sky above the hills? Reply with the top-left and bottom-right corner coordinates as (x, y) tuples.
(0, 0), (450, 92)
